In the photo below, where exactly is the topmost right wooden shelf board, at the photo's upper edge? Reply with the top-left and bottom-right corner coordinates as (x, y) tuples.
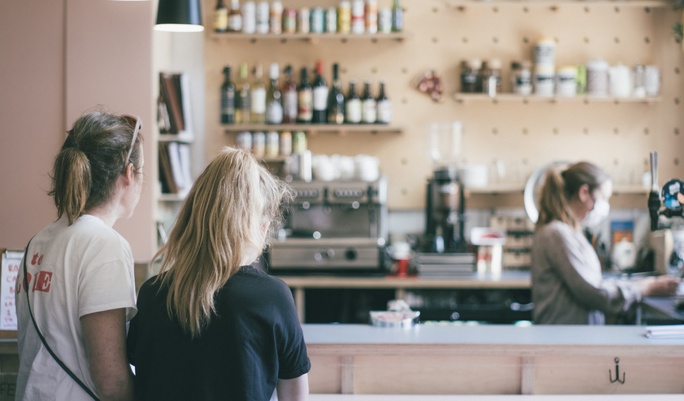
(449, 0), (673, 11)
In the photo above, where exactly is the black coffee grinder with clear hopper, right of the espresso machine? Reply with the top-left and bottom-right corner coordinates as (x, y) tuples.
(421, 121), (466, 253)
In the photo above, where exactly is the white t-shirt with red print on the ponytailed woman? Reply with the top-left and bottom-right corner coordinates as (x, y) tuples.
(16, 215), (137, 401)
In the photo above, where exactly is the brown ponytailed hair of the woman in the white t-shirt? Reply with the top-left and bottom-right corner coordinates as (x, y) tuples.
(49, 111), (143, 224)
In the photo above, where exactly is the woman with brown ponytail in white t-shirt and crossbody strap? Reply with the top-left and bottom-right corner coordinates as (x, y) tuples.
(16, 111), (144, 401)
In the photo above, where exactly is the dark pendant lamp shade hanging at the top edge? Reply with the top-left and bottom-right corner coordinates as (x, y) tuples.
(154, 0), (204, 32)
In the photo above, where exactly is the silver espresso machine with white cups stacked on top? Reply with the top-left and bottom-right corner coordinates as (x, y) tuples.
(268, 177), (388, 274)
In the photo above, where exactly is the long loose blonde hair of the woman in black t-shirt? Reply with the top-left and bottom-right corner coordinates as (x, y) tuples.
(153, 147), (292, 338)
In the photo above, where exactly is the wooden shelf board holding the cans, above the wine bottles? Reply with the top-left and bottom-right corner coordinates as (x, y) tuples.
(211, 32), (408, 43)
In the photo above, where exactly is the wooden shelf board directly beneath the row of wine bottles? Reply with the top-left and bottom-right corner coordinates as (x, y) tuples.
(221, 124), (404, 135)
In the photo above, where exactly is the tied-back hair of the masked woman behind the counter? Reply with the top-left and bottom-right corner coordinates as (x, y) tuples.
(536, 162), (610, 228)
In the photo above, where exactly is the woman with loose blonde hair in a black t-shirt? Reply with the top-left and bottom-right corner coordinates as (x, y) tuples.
(128, 148), (310, 401)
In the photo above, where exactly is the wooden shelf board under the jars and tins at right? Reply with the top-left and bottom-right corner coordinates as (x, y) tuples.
(454, 93), (662, 104)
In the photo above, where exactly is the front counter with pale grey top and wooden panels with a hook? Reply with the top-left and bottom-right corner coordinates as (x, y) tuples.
(304, 325), (684, 395)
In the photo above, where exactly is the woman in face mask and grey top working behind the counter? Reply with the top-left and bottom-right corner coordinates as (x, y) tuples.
(532, 162), (678, 324)
